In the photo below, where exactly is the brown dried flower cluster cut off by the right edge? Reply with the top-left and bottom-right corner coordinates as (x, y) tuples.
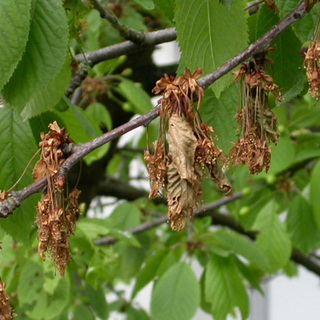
(304, 21), (320, 98)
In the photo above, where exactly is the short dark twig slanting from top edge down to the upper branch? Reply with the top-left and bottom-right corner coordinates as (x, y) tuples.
(90, 0), (145, 44)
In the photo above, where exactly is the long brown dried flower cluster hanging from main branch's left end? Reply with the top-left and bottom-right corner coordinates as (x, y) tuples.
(33, 122), (80, 276)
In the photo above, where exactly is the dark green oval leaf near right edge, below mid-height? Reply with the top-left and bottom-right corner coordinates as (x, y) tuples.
(286, 195), (320, 253)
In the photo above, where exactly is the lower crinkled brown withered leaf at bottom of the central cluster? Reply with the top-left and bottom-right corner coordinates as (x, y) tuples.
(166, 163), (201, 231)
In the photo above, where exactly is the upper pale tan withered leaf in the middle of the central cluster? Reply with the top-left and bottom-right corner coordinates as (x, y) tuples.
(168, 114), (197, 184)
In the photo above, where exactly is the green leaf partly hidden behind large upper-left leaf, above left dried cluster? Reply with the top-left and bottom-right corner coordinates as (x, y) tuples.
(21, 59), (71, 120)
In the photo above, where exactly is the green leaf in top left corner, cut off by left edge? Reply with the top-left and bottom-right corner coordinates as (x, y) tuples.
(0, 0), (31, 91)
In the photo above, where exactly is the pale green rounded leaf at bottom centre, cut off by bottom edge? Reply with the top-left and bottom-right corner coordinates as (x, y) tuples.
(151, 263), (200, 320)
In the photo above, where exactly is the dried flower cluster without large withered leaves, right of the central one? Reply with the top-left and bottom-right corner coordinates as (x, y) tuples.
(230, 57), (279, 174)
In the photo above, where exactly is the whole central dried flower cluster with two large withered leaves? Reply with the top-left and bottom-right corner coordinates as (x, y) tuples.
(145, 69), (231, 231)
